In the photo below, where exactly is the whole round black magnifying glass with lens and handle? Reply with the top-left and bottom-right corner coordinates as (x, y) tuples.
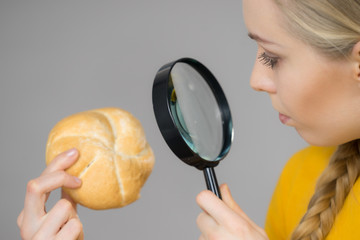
(152, 58), (234, 199)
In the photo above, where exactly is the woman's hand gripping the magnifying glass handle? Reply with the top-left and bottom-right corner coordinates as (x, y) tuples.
(196, 184), (268, 240)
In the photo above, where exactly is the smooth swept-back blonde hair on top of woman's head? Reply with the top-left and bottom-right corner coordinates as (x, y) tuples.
(275, 0), (360, 57)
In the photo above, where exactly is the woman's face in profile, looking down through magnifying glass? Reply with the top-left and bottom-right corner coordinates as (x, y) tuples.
(243, 0), (360, 146)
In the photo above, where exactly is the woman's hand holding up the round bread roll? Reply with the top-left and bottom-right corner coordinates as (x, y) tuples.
(17, 149), (84, 240)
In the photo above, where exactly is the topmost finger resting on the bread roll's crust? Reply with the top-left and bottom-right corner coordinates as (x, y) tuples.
(41, 148), (79, 175)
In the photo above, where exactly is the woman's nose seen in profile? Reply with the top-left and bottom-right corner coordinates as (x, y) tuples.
(250, 61), (276, 93)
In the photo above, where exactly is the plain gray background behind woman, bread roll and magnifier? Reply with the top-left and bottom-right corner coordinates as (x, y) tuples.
(0, 0), (306, 240)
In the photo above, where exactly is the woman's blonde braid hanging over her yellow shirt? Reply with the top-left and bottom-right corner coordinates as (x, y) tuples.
(291, 140), (360, 240)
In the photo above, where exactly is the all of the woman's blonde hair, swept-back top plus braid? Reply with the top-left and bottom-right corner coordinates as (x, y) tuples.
(274, 0), (360, 240)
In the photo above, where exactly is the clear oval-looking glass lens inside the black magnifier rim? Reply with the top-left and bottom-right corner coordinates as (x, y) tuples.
(169, 62), (224, 161)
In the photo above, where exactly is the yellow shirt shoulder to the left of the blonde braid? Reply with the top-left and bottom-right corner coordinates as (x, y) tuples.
(265, 146), (335, 240)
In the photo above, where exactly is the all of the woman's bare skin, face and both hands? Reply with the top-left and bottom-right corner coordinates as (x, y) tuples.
(18, 0), (360, 240)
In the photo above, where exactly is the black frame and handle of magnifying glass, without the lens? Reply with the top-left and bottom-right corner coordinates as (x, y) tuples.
(152, 58), (233, 199)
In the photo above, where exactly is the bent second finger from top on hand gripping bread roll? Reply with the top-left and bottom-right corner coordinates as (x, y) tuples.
(23, 171), (81, 222)
